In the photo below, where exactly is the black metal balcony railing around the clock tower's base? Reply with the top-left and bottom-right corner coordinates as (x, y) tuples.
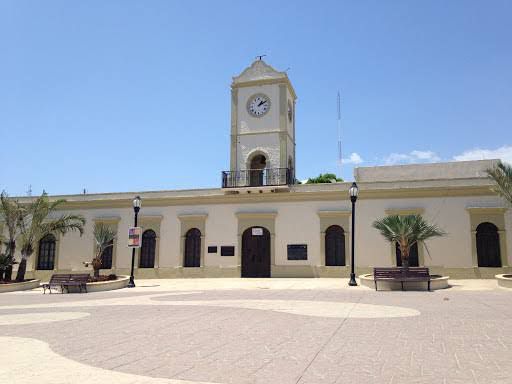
(222, 168), (293, 188)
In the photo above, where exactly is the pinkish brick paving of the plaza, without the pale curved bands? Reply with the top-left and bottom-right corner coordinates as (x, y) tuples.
(0, 280), (512, 384)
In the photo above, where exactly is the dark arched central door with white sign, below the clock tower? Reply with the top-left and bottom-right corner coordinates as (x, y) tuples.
(242, 227), (270, 277)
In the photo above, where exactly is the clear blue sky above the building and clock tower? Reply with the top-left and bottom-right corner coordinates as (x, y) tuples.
(0, 0), (512, 195)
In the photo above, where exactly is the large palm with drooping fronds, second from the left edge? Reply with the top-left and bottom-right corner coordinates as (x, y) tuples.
(16, 192), (85, 281)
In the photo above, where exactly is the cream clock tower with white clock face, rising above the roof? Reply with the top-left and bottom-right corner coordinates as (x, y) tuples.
(223, 59), (297, 188)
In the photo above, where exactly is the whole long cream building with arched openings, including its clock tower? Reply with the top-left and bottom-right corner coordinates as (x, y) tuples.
(5, 60), (512, 279)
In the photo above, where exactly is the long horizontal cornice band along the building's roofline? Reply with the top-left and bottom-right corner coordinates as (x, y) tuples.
(11, 178), (496, 209)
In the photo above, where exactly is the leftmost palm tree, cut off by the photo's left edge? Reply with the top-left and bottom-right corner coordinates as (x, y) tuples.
(0, 191), (20, 281)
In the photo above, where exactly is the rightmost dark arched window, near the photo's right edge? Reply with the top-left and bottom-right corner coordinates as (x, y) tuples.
(476, 223), (501, 267)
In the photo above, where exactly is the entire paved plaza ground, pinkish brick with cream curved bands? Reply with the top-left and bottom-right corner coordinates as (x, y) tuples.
(0, 279), (512, 384)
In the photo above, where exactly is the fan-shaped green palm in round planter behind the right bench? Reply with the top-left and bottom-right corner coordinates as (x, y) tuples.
(373, 215), (446, 269)
